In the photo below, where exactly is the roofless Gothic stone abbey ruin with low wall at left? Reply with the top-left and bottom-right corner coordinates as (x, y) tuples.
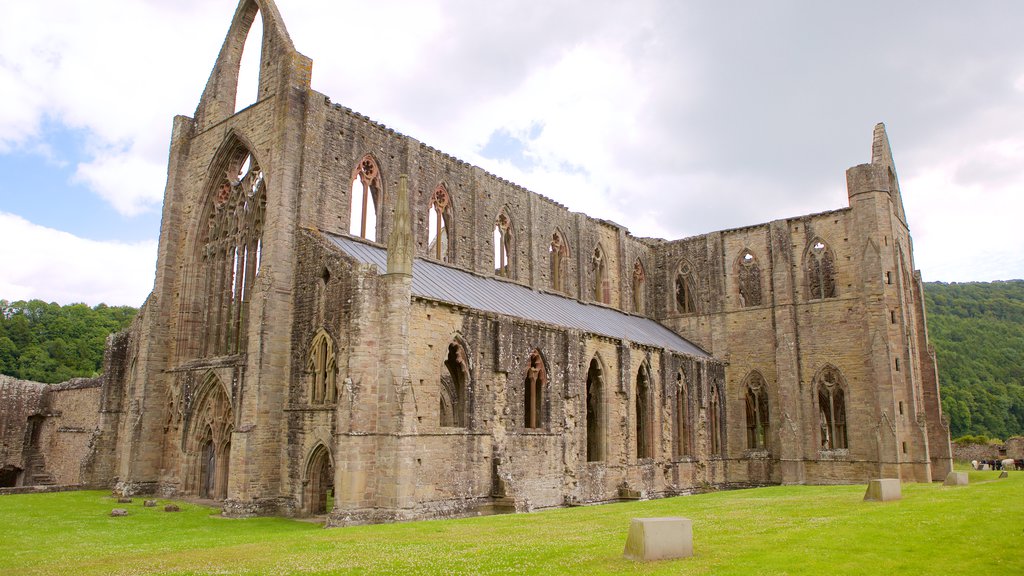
(0, 0), (951, 525)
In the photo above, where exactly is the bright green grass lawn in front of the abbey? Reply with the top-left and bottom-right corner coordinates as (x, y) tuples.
(0, 471), (1024, 576)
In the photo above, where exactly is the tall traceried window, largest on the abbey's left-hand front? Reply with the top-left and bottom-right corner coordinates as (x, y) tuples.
(200, 143), (266, 356)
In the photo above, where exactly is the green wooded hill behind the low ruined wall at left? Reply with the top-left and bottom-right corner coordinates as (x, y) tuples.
(0, 300), (138, 383)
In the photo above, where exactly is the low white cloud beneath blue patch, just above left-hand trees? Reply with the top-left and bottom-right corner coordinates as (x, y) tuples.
(0, 212), (157, 306)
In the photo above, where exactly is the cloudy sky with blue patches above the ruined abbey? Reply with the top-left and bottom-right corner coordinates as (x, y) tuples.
(0, 0), (1024, 305)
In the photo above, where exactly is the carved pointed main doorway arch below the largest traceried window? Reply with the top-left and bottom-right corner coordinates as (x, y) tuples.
(182, 372), (234, 500)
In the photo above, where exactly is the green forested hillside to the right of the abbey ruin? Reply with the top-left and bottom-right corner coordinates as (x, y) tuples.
(925, 280), (1024, 440)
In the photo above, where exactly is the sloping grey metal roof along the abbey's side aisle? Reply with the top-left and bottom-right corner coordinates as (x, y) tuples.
(324, 234), (708, 357)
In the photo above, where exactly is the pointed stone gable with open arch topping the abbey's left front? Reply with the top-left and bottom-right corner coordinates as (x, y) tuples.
(195, 0), (299, 131)
